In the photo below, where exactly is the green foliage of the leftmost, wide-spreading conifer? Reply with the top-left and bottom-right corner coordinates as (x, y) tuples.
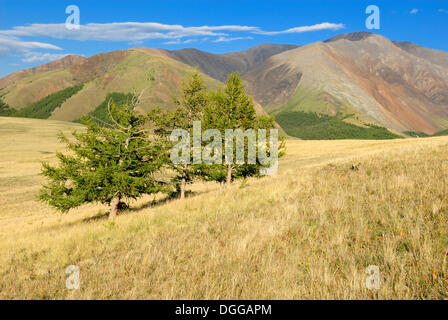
(40, 99), (170, 212)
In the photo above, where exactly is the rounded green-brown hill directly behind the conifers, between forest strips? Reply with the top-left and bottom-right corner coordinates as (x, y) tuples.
(51, 49), (221, 120)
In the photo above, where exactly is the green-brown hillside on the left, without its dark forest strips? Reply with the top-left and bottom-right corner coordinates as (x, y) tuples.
(0, 48), (226, 121)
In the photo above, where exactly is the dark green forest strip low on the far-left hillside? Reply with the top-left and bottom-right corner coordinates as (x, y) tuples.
(0, 84), (83, 119)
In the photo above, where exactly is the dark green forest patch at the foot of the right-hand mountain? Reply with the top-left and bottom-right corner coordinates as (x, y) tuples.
(276, 111), (399, 140)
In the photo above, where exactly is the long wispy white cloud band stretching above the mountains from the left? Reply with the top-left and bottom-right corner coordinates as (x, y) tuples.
(0, 22), (345, 63)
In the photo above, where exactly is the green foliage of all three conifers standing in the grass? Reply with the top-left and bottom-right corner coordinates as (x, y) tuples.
(40, 71), (288, 216)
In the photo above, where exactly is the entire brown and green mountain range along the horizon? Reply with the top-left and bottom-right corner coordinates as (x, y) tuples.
(0, 32), (448, 138)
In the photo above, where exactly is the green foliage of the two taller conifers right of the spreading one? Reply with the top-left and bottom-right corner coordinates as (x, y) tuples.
(150, 70), (284, 187)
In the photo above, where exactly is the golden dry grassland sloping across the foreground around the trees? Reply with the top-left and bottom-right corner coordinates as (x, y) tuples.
(0, 118), (448, 299)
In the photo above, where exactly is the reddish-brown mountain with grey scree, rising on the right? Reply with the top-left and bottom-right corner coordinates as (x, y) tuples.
(243, 33), (448, 134)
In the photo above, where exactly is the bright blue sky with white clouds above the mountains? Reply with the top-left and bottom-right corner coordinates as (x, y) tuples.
(0, 0), (448, 77)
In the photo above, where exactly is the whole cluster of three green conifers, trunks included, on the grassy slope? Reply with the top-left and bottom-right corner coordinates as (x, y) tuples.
(39, 69), (285, 218)
